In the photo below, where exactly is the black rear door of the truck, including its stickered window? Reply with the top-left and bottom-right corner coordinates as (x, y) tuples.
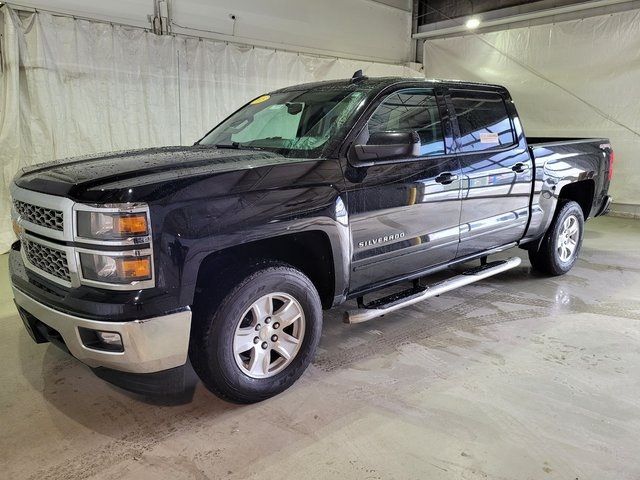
(448, 89), (533, 257)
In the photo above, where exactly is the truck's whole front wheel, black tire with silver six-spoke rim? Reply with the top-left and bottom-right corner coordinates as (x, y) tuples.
(191, 263), (322, 403)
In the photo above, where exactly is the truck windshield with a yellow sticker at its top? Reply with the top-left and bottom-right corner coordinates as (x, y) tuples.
(199, 89), (365, 157)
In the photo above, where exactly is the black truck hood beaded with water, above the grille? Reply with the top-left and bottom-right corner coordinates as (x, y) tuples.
(15, 145), (297, 199)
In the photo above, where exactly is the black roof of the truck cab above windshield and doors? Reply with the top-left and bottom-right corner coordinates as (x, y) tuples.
(272, 76), (506, 93)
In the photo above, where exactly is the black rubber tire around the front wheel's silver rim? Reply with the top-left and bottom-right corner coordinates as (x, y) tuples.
(190, 262), (322, 403)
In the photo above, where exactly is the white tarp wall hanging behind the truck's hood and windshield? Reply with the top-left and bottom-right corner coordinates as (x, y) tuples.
(0, 6), (421, 252)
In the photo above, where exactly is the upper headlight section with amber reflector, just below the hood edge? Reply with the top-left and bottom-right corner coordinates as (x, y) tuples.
(78, 210), (149, 240)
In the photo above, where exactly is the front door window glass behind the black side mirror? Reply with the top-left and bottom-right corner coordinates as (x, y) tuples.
(369, 88), (444, 155)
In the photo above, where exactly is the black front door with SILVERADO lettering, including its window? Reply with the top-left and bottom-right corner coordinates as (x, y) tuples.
(345, 88), (461, 292)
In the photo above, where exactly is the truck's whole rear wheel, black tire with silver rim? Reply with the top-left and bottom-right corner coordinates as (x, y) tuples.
(529, 200), (584, 275)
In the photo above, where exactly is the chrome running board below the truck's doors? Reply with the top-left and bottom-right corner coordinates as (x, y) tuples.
(344, 257), (522, 324)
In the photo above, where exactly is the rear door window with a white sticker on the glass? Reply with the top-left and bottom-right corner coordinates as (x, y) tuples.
(451, 91), (515, 152)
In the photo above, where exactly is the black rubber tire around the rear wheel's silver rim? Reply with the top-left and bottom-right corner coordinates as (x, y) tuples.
(529, 200), (584, 276)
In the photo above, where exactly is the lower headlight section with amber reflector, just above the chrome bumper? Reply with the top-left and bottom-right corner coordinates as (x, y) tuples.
(80, 253), (151, 284)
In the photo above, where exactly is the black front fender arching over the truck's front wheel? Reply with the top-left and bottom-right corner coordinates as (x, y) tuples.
(156, 186), (351, 305)
